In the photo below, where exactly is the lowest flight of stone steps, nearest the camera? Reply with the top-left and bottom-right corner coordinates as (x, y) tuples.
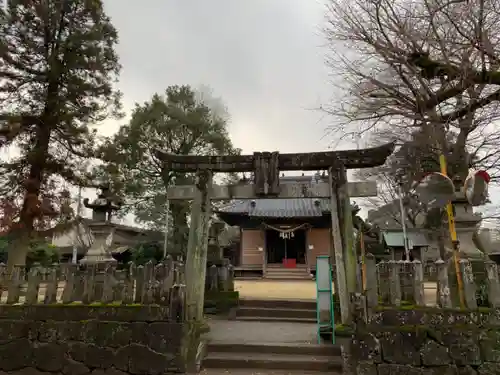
(203, 342), (342, 374)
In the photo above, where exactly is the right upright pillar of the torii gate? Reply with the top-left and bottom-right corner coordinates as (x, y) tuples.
(328, 168), (350, 324)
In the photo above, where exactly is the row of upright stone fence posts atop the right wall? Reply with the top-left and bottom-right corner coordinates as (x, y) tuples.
(364, 254), (500, 309)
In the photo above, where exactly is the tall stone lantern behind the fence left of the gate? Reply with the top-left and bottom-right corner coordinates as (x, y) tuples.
(80, 185), (122, 265)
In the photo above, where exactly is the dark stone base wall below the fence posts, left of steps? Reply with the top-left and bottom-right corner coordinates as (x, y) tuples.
(0, 305), (189, 375)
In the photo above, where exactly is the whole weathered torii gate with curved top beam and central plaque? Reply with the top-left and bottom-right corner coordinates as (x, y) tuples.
(157, 143), (394, 322)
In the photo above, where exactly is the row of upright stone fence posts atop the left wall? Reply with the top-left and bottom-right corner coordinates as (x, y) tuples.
(0, 257), (185, 320)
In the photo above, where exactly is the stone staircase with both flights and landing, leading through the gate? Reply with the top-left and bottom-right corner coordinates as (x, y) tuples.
(202, 299), (342, 375)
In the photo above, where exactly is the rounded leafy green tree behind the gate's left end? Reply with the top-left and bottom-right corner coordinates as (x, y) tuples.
(96, 85), (240, 252)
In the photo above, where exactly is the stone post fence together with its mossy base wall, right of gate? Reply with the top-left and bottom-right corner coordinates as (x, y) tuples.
(342, 255), (500, 375)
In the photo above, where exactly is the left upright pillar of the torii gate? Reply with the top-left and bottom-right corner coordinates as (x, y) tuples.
(186, 171), (212, 321)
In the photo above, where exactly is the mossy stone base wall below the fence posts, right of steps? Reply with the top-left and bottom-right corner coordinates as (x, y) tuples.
(343, 309), (500, 375)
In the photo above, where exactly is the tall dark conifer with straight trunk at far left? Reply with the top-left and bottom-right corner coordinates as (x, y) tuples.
(0, 0), (120, 265)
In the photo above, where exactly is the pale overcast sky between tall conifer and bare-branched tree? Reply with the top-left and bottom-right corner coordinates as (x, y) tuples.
(102, 0), (332, 153)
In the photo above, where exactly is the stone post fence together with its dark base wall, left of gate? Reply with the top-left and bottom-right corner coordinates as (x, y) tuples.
(0, 258), (205, 375)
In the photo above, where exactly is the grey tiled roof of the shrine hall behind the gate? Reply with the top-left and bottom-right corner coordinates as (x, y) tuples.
(218, 198), (330, 218)
